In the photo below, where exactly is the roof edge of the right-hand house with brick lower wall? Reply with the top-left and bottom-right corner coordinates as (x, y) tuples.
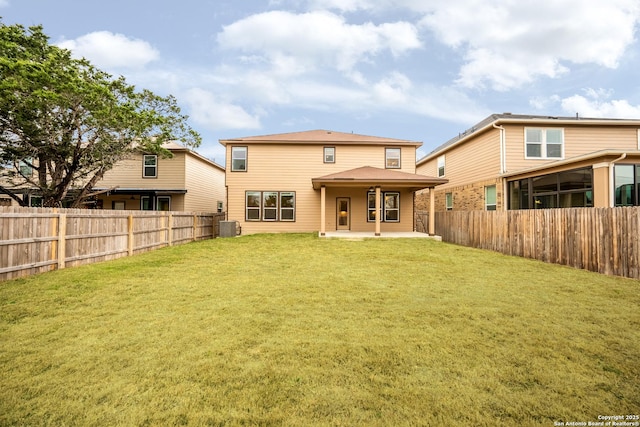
(417, 113), (640, 165)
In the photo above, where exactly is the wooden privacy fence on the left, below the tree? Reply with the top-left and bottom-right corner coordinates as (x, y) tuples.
(0, 207), (224, 280)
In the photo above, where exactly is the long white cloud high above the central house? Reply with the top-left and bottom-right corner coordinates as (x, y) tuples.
(218, 11), (421, 75)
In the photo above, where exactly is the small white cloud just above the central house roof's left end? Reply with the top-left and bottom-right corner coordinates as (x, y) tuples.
(182, 88), (260, 130)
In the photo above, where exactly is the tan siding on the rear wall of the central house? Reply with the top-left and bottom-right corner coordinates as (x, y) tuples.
(226, 144), (415, 234)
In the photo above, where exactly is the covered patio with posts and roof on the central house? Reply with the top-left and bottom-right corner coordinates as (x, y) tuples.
(311, 166), (447, 238)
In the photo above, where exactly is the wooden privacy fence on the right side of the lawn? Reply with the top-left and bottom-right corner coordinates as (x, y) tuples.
(417, 207), (640, 279)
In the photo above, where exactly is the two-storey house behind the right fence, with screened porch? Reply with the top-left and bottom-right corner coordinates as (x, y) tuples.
(416, 113), (640, 211)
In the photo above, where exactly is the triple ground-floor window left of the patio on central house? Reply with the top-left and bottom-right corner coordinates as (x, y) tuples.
(245, 191), (296, 221)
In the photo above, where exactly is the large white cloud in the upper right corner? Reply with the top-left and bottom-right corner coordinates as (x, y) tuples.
(421, 0), (640, 90)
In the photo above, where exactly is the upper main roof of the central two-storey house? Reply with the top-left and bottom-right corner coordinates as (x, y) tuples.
(220, 129), (422, 146)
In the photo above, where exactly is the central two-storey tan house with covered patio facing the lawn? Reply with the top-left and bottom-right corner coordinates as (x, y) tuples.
(220, 130), (446, 235)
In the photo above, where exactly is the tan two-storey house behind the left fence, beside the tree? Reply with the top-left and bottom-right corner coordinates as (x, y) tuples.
(94, 142), (226, 212)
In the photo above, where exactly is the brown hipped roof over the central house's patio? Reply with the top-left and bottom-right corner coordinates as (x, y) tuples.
(311, 166), (449, 190)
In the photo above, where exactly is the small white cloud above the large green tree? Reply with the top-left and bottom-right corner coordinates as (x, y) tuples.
(58, 31), (160, 69)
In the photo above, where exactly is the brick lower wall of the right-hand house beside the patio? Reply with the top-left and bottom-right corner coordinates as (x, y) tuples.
(415, 179), (504, 212)
